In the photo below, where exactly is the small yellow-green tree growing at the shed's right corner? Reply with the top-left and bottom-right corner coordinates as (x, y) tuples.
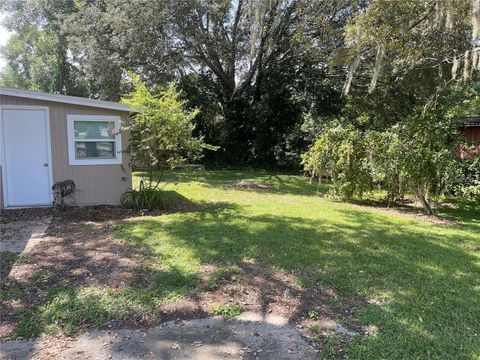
(122, 74), (216, 188)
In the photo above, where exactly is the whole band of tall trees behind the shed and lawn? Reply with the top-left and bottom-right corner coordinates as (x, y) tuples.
(0, 0), (480, 168)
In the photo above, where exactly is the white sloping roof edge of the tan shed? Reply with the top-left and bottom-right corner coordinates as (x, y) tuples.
(0, 86), (131, 112)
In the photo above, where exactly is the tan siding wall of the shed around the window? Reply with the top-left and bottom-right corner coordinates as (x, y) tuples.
(0, 95), (132, 205)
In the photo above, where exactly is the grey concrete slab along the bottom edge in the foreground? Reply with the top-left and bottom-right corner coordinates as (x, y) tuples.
(0, 312), (318, 360)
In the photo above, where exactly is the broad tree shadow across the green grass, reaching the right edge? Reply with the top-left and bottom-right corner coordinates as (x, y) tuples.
(118, 204), (480, 358)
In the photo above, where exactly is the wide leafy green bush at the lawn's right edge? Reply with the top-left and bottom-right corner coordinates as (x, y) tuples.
(302, 113), (464, 215)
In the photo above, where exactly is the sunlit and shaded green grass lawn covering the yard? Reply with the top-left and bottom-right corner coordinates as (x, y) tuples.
(0, 170), (480, 359)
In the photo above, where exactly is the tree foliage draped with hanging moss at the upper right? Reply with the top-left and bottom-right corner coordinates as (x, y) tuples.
(344, 0), (472, 97)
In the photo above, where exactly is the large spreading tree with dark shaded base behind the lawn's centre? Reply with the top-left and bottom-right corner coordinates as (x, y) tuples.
(62, 0), (366, 164)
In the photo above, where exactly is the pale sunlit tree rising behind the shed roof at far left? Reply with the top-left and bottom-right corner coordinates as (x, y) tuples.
(0, 0), (88, 96)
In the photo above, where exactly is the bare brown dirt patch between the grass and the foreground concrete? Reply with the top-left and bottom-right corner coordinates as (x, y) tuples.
(157, 262), (368, 358)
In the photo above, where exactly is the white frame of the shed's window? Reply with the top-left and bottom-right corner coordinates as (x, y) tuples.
(67, 114), (122, 165)
